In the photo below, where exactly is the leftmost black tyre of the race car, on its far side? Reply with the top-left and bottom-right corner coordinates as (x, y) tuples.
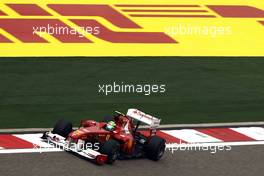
(52, 119), (72, 138)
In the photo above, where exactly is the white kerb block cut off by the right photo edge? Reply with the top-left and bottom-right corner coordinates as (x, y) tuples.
(231, 127), (264, 141)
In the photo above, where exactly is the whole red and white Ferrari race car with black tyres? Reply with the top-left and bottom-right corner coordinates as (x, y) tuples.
(42, 109), (165, 164)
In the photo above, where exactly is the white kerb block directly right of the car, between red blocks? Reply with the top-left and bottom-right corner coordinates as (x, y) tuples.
(162, 129), (223, 143)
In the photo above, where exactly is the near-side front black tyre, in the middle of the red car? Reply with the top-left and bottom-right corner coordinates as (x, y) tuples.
(100, 139), (120, 164)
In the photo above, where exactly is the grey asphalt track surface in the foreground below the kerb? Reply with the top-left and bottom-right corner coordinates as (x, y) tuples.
(0, 145), (264, 176)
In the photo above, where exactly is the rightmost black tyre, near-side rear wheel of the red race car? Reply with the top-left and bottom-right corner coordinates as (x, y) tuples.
(145, 136), (166, 161)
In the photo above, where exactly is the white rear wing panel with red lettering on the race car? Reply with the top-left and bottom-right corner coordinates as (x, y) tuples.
(127, 109), (161, 128)
